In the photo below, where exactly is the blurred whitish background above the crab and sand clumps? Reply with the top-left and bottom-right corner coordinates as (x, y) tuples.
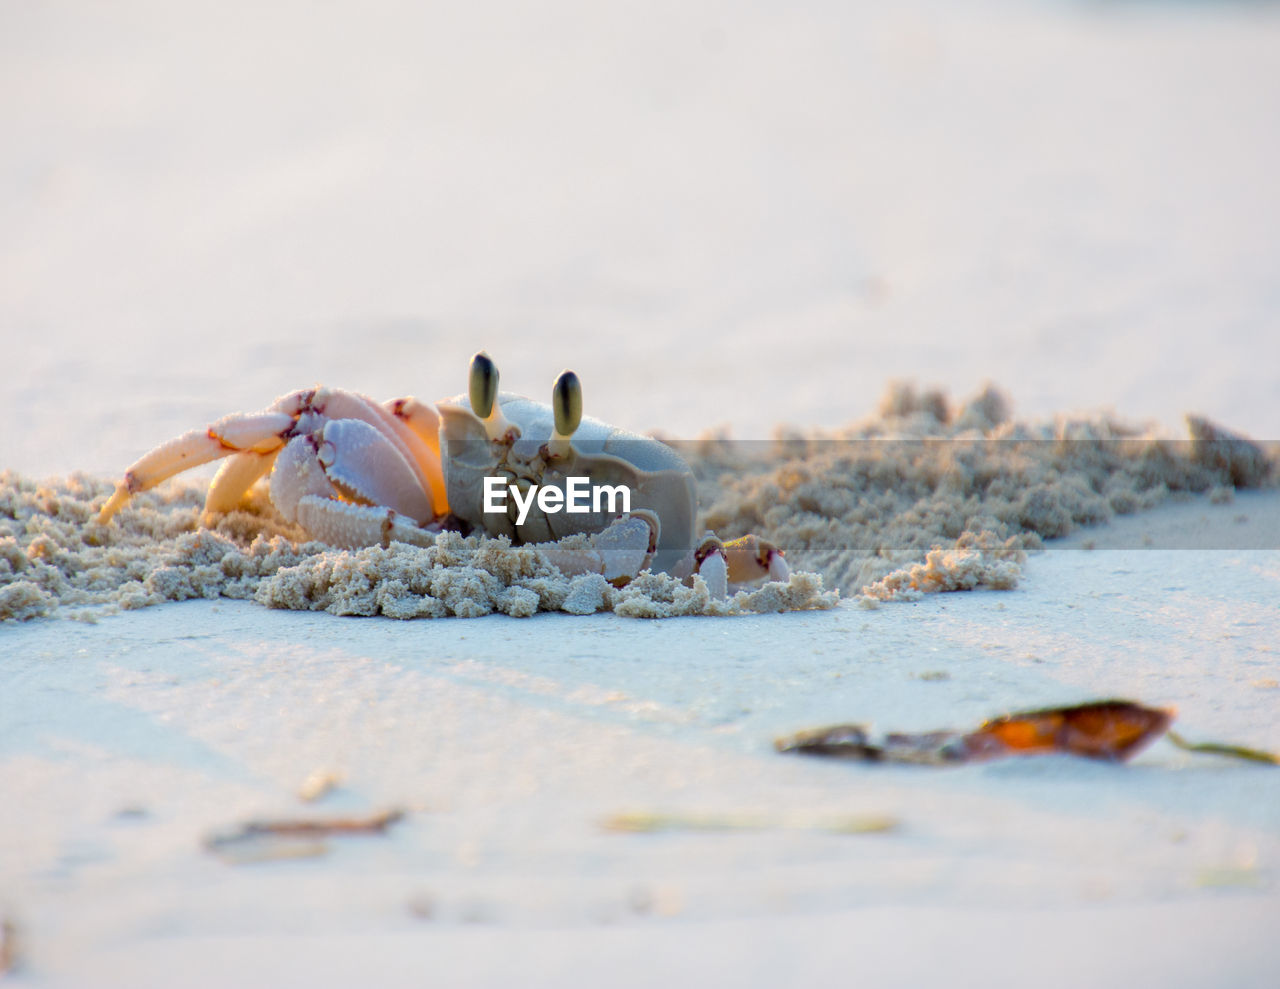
(0, 0), (1280, 475)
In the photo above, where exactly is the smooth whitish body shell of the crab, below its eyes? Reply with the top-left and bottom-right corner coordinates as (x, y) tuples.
(436, 393), (698, 572)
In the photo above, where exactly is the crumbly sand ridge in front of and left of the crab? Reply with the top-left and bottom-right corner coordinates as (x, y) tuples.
(0, 473), (838, 621)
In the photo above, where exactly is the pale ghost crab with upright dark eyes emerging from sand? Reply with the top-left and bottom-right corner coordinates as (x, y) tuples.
(97, 353), (790, 597)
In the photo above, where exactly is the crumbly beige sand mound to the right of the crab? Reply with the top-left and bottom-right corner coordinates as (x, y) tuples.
(681, 385), (1280, 600)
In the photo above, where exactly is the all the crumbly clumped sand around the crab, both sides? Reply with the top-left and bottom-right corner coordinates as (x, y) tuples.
(0, 386), (1276, 619)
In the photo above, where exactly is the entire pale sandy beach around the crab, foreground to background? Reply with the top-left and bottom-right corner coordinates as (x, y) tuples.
(0, 0), (1280, 989)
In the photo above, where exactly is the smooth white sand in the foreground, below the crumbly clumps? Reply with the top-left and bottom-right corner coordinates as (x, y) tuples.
(0, 493), (1280, 985)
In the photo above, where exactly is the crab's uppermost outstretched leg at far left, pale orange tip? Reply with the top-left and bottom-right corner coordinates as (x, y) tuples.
(97, 412), (293, 523)
